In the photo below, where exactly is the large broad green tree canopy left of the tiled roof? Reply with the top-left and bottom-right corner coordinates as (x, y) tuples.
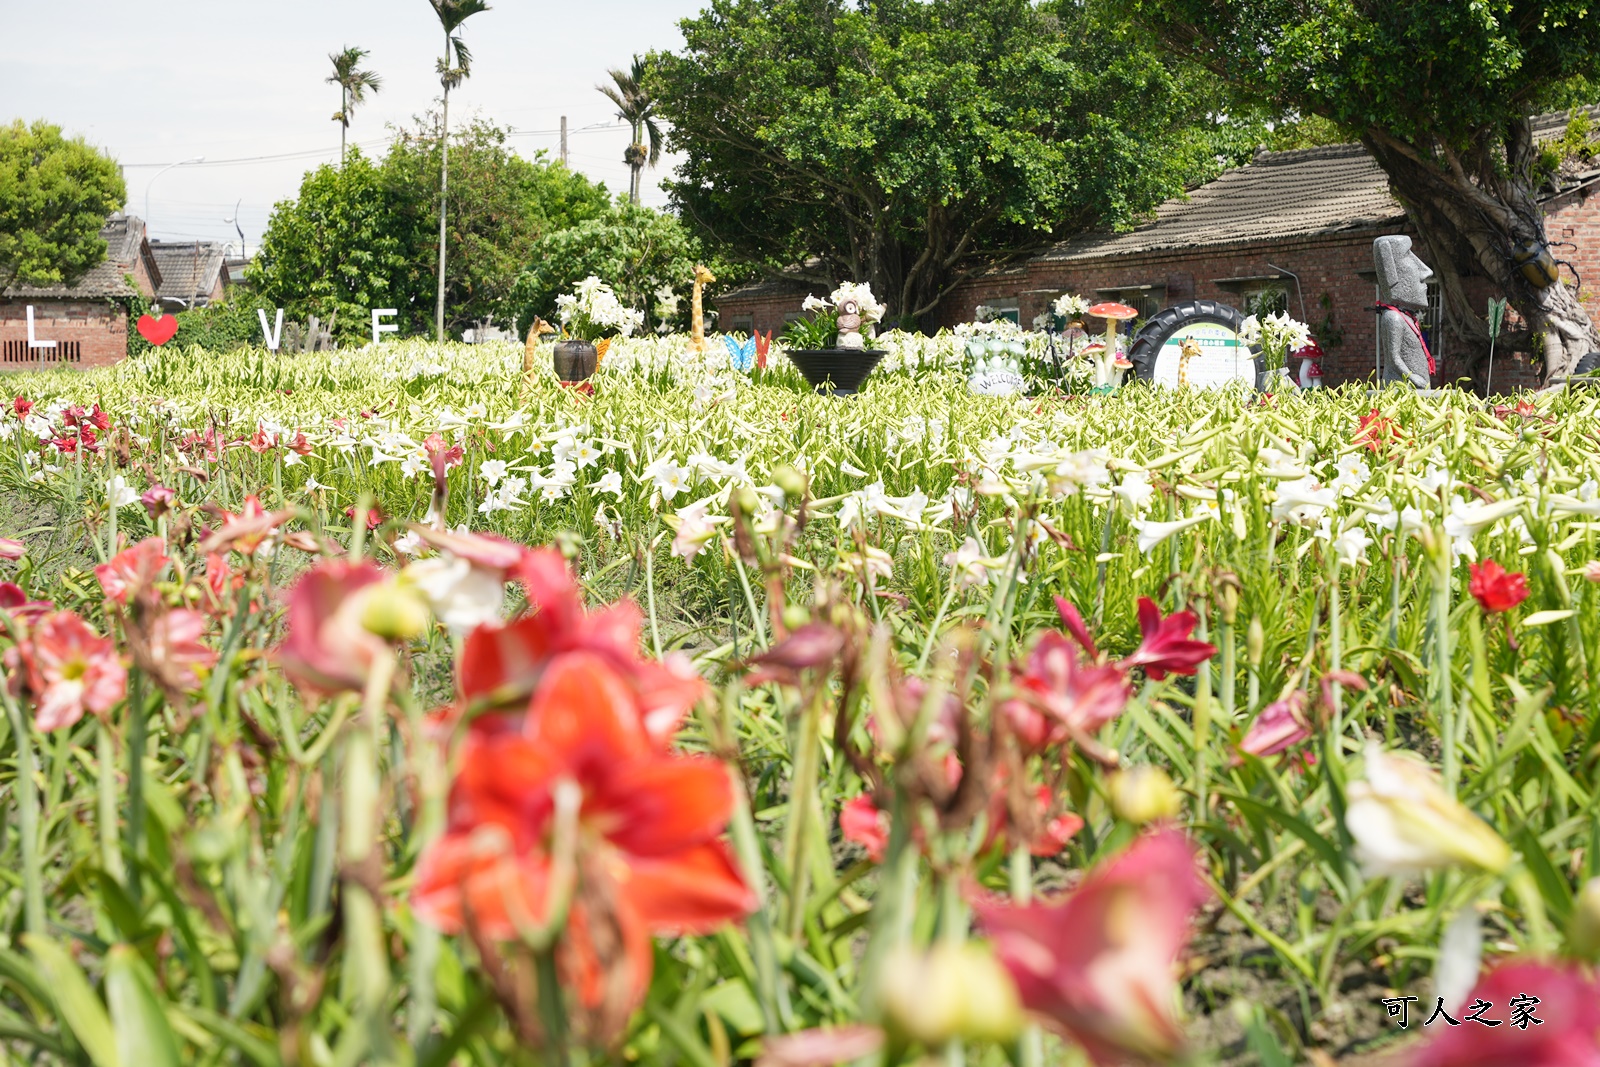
(651, 0), (1254, 320)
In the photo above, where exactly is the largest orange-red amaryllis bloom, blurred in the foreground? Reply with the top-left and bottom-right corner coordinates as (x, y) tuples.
(411, 653), (755, 1019)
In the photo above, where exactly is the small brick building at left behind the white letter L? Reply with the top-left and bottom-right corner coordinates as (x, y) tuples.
(0, 214), (162, 371)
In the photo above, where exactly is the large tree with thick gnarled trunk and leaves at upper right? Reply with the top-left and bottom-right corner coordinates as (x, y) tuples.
(1110, 0), (1600, 378)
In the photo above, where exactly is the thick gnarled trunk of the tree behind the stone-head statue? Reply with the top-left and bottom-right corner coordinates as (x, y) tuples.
(1362, 120), (1600, 386)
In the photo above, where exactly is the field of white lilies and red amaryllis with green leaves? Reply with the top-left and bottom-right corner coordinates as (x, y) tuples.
(0, 334), (1600, 1067)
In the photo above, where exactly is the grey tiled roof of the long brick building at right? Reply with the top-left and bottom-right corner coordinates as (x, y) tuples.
(1040, 144), (1405, 262)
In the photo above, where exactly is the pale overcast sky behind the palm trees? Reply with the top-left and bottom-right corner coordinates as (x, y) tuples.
(0, 0), (701, 251)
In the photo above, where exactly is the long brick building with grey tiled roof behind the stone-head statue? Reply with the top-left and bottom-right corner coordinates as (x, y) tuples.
(717, 115), (1600, 390)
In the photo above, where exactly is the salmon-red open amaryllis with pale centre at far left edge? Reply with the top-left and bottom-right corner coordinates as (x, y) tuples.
(5, 611), (128, 733)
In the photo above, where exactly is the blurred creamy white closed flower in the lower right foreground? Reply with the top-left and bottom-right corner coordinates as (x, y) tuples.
(1344, 742), (1510, 877)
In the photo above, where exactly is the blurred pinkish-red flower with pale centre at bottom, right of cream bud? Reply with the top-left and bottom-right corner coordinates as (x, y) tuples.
(976, 830), (1210, 1064)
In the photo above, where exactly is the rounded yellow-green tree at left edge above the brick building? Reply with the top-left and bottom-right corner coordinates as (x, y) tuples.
(0, 120), (128, 290)
